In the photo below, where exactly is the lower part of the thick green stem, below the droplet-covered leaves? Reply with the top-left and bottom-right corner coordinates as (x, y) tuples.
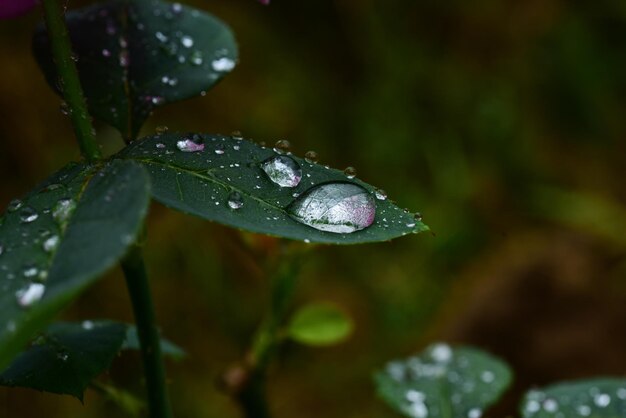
(122, 244), (173, 418)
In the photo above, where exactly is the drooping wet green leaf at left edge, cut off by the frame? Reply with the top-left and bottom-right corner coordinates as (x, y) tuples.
(0, 161), (150, 370)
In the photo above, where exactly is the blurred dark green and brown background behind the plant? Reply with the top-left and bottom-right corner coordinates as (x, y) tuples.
(0, 0), (626, 418)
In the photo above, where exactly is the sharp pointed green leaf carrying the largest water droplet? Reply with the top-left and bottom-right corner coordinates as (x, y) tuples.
(118, 134), (428, 244)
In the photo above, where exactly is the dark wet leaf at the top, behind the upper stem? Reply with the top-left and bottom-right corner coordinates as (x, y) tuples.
(33, 0), (237, 138)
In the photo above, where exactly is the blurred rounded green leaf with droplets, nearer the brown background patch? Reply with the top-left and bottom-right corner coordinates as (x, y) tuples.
(375, 343), (511, 418)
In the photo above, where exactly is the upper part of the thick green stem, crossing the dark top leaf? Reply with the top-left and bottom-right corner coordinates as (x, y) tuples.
(42, 0), (102, 161)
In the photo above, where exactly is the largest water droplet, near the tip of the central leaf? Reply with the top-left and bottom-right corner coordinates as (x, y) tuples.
(287, 183), (376, 234)
